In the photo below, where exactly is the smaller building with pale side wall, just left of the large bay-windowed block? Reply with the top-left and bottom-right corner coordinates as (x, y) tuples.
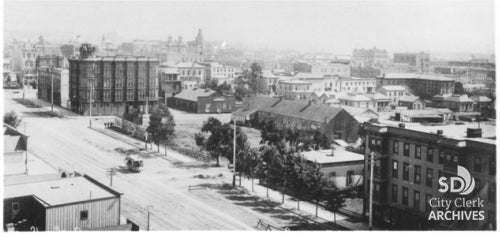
(38, 67), (70, 108)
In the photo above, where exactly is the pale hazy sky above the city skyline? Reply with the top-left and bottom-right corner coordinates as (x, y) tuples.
(4, 0), (495, 54)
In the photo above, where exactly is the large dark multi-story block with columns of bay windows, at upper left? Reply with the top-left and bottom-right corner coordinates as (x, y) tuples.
(69, 44), (159, 115)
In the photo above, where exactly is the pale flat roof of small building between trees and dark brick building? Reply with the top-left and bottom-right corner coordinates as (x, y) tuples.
(300, 148), (365, 164)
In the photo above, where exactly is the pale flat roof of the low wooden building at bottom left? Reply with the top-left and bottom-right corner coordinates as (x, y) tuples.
(4, 176), (116, 207)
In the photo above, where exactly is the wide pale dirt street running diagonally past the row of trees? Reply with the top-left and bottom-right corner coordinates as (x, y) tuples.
(4, 90), (316, 230)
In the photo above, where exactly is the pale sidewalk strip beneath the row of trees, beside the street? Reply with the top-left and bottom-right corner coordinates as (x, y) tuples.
(236, 178), (377, 230)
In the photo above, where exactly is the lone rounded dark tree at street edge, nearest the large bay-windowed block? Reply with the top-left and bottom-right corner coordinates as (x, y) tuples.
(146, 104), (175, 155)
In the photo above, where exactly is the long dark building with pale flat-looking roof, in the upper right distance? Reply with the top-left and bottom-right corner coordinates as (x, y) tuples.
(376, 73), (455, 99)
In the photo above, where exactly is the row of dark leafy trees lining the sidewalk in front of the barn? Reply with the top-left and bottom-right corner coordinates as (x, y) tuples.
(191, 117), (350, 220)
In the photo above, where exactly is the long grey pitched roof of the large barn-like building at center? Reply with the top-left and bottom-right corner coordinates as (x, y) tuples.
(259, 100), (344, 123)
